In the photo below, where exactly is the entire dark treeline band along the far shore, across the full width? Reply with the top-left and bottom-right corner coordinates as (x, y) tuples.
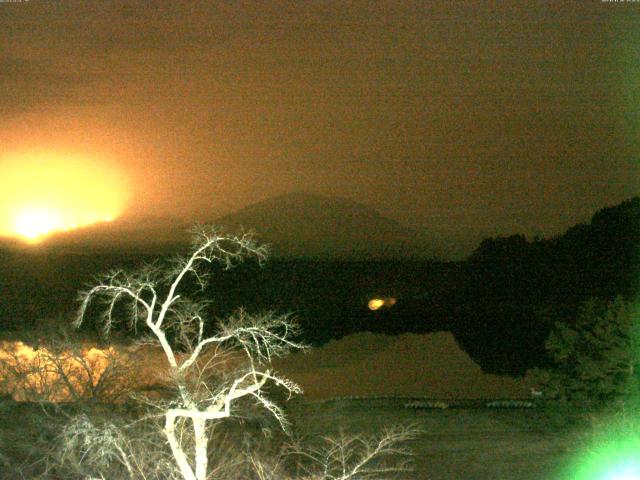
(0, 198), (640, 375)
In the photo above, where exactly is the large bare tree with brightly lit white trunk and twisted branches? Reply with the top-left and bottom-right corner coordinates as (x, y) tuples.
(75, 227), (303, 480)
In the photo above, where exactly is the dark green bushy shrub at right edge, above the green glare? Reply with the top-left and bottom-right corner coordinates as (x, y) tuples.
(536, 297), (640, 413)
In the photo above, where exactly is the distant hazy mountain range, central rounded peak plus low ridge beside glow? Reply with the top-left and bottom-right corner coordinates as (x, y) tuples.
(7, 192), (432, 260)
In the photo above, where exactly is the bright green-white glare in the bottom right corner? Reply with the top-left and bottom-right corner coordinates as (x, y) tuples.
(560, 435), (640, 480)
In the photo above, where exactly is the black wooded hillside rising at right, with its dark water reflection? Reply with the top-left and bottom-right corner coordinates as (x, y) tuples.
(447, 197), (640, 374)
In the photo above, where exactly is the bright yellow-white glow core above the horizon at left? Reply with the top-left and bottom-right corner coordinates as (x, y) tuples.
(0, 153), (126, 243)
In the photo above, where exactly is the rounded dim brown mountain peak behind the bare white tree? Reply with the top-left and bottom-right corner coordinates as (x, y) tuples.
(215, 192), (429, 259)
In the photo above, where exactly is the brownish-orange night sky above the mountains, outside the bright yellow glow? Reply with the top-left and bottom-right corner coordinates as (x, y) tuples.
(0, 0), (640, 256)
